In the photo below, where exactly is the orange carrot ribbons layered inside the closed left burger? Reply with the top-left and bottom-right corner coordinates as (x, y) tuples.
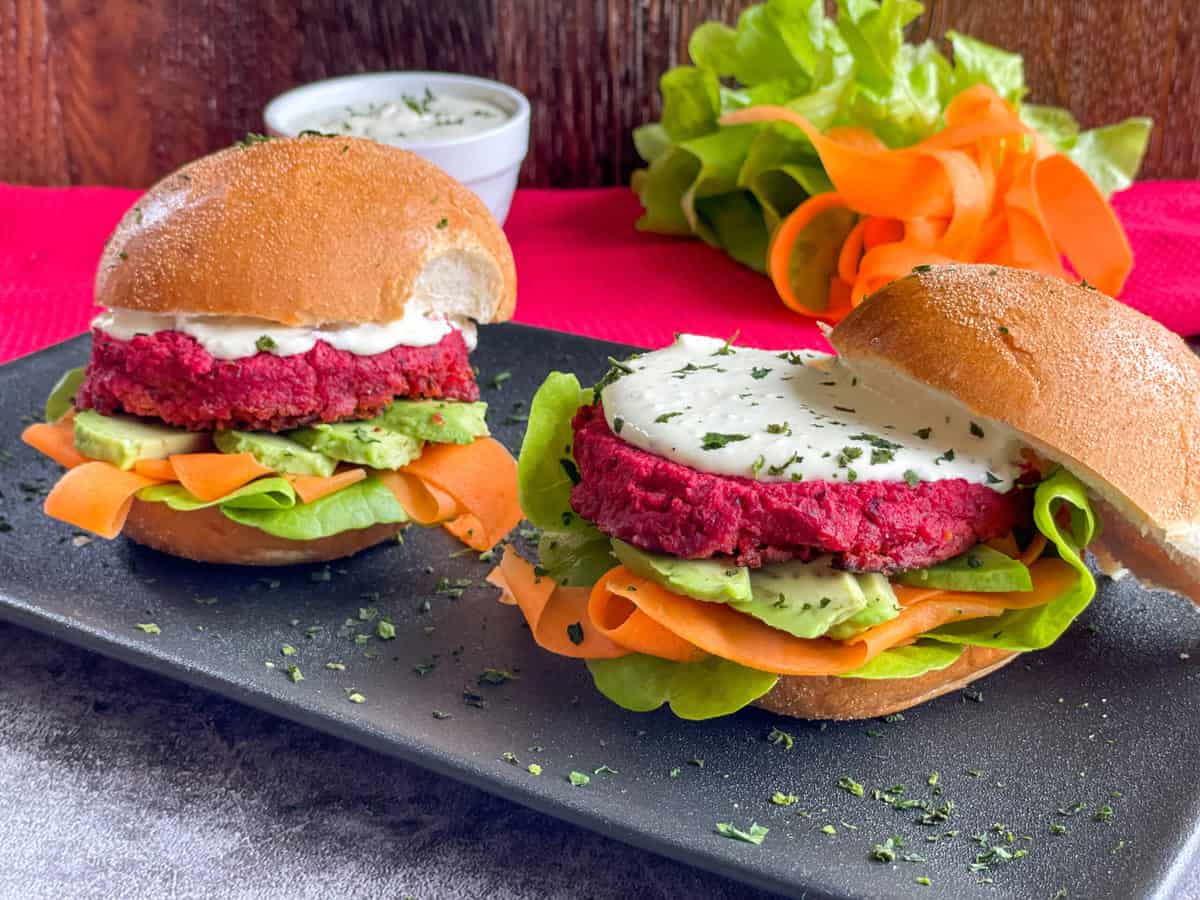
(22, 416), (521, 551)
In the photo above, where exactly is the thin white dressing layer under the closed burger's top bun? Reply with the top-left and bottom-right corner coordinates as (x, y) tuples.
(91, 305), (475, 360)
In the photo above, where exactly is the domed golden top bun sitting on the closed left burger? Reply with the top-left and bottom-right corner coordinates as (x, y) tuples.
(96, 136), (516, 325)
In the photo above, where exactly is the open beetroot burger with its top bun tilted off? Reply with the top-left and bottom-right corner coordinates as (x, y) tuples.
(491, 266), (1200, 719)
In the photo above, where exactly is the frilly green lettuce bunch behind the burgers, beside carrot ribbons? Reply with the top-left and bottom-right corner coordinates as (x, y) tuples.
(632, 0), (1150, 274)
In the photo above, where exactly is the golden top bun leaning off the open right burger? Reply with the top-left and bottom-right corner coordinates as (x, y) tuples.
(830, 265), (1200, 602)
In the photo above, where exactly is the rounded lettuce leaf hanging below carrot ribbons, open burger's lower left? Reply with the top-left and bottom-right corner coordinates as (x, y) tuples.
(587, 653), (779, 720)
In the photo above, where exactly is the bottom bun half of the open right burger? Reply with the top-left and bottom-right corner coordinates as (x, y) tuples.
(755, 647), (1018, 719)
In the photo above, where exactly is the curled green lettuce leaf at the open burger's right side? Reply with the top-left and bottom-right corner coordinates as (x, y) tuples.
(924, 469), (1098, 650)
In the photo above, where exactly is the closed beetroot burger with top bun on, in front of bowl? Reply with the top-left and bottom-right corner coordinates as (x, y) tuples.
(24, 136), (520, 565)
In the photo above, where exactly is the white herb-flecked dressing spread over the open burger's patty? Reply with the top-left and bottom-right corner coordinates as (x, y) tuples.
(602, 335), (1021, 492)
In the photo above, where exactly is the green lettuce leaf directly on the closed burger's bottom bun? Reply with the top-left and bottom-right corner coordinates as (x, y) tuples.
(221, 476), (408, 541)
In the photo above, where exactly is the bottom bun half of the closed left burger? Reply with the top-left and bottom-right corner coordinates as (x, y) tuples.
(121, 500), (404, 565)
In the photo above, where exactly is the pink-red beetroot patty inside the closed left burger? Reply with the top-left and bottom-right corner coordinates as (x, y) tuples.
(76, 330), (479, 431)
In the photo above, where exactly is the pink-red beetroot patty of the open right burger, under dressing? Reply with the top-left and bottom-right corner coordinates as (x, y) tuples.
(571, 404), (1024, 574)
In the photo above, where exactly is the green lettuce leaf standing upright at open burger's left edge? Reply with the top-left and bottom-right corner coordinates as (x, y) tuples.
(517, 372), (617, 584)
